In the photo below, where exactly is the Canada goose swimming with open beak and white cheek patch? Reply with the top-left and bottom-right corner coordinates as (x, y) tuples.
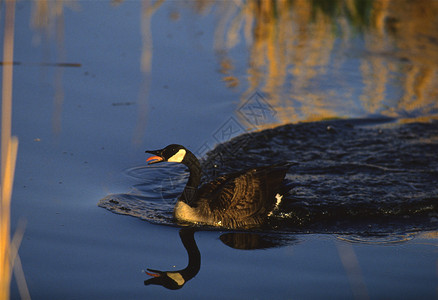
(146, 145), (289, 228)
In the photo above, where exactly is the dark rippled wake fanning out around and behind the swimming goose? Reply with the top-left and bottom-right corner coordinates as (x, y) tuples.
(99, 119), (438, 234)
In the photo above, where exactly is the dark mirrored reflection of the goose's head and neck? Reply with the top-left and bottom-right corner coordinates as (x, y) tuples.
(144, 229), (201, 290)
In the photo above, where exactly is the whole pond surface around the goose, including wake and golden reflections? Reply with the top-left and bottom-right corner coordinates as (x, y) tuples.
(6, 0), (438, 299)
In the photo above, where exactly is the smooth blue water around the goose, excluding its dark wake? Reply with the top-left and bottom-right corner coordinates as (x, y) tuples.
(6, 1), (438, 299)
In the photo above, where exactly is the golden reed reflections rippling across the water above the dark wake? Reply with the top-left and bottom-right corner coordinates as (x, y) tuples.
(32, 0), (438, 128)
